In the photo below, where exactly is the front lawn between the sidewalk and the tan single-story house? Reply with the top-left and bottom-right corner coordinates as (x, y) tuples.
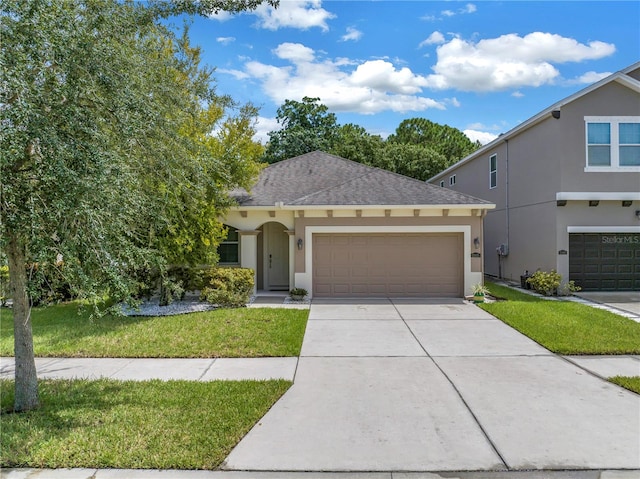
(0, 303), (309, 358)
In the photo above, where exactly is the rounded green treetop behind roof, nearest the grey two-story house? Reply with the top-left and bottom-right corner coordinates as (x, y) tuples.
(387, 118), (481, 168)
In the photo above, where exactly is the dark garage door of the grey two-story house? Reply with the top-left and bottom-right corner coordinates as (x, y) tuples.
(569, 233), (640, 291)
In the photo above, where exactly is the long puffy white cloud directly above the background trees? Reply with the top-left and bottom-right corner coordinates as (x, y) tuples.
(240, 43), (445, 114)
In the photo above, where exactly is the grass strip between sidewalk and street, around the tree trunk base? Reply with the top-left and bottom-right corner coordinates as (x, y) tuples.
(0, 380), (291, 469)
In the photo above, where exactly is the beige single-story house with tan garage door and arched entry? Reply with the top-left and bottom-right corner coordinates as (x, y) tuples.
(219, 151), (494, 297)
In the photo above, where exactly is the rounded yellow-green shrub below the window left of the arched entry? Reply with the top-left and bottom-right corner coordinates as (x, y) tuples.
(200, 268), (254, 308)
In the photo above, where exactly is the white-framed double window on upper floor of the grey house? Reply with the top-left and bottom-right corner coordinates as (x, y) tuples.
(585, 117), (640, 171)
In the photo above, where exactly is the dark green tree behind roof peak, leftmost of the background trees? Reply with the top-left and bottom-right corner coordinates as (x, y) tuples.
(263, 97), (338, 163)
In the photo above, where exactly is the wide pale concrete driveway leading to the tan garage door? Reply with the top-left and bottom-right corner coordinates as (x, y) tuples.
(224, 299), (640, 471)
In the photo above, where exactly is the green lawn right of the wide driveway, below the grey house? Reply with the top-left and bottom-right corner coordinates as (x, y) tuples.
(481, 283), (640, 354)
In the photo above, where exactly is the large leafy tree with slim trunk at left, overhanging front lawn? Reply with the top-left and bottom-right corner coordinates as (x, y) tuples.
(0, 0), (276, 411)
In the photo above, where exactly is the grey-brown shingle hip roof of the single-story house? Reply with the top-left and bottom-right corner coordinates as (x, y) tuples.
(232, 151), (490, 206)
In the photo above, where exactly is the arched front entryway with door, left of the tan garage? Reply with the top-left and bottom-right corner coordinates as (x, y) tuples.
(263, 222), (289, 291)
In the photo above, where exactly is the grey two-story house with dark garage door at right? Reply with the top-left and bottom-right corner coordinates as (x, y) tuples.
(428, 62), (640, 291)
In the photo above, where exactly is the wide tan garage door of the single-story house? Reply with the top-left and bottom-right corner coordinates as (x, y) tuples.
(313, 233), (464, 297)
